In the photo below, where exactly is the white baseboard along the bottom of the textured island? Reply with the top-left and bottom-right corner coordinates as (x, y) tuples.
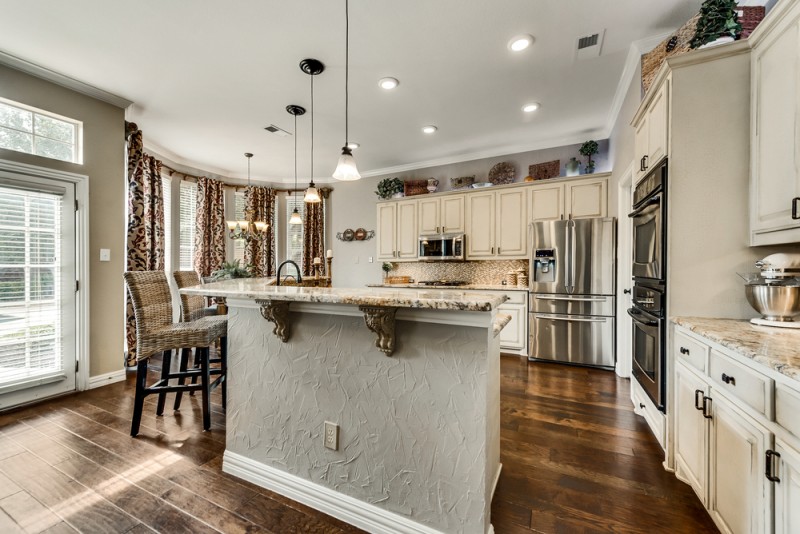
(222, 451), (494, 534)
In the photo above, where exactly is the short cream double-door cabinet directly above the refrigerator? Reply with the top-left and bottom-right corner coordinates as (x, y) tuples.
(529, 176), (608, 222)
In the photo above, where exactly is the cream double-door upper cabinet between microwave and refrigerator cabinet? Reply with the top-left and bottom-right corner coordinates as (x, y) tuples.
(466, 192), (528, 260)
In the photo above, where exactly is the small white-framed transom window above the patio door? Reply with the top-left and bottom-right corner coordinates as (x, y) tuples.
(0, 98), (83, 163)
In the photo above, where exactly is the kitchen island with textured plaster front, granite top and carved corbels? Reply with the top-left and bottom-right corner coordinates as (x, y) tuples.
(181, 279), (509, 533)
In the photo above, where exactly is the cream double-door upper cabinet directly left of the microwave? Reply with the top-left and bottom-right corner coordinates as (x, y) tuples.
(377, 200), (419, 261)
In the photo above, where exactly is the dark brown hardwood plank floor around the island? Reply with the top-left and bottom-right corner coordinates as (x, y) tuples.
(0, 356), (716, 534)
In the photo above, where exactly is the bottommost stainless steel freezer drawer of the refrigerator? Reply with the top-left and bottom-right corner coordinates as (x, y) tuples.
(528, 313), (616, 368)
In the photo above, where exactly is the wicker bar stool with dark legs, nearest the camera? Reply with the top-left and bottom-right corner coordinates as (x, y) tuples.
(124, 271), (227, 436)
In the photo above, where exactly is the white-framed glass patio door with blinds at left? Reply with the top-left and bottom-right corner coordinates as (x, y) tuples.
(0, 172), (77, 410)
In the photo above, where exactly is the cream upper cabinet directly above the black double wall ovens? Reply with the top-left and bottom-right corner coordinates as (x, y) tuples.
(633, 79), (670, 184)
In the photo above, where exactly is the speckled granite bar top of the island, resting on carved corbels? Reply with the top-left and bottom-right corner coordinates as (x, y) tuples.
(180, 278), (508, 311)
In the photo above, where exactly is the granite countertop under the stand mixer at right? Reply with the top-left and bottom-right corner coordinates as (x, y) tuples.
(672, 317), (800, 380)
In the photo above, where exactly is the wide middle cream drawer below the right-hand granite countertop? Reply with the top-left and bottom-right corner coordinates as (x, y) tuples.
(708, 350), (773, 419)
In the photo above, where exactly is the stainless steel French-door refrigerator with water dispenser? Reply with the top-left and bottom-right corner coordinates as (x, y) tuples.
(528, 217), (617, 369)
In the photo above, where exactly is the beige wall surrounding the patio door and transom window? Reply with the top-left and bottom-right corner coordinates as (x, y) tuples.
(0, 65), (126, 376)
